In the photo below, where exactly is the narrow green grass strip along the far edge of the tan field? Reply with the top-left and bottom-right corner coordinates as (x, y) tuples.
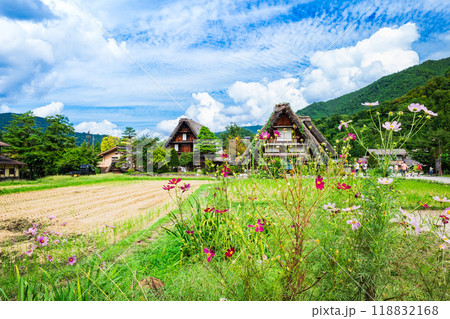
(0, 174), (211, 195)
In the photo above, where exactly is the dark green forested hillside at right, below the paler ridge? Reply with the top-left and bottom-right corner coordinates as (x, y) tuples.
(314, 69), (450, 172)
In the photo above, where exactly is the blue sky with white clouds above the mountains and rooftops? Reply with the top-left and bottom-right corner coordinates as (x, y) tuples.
(0, 0), (450, 136)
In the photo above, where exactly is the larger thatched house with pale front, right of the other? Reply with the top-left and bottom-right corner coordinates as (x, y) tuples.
(244, 103), (335, 162)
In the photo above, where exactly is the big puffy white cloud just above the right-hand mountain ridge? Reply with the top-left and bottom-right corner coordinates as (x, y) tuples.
(302, 23), (419, 102)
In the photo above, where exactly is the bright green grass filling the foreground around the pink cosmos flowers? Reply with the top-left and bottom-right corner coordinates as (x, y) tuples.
(0, 175), (450, 300)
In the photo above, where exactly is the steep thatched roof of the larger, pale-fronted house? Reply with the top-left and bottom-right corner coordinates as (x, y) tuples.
(244, 103), (335, 159)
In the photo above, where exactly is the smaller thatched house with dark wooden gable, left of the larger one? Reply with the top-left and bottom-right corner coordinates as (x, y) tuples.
(164, 118), (202, 155)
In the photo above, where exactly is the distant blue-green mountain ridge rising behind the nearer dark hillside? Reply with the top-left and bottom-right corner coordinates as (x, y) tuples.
(297, 57), (450, 119)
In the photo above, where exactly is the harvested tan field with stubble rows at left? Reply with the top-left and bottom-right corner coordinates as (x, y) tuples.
(0, 181), (207, 242)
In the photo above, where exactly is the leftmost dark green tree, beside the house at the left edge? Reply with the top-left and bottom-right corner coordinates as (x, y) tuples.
(3, 112), (46, 178)
